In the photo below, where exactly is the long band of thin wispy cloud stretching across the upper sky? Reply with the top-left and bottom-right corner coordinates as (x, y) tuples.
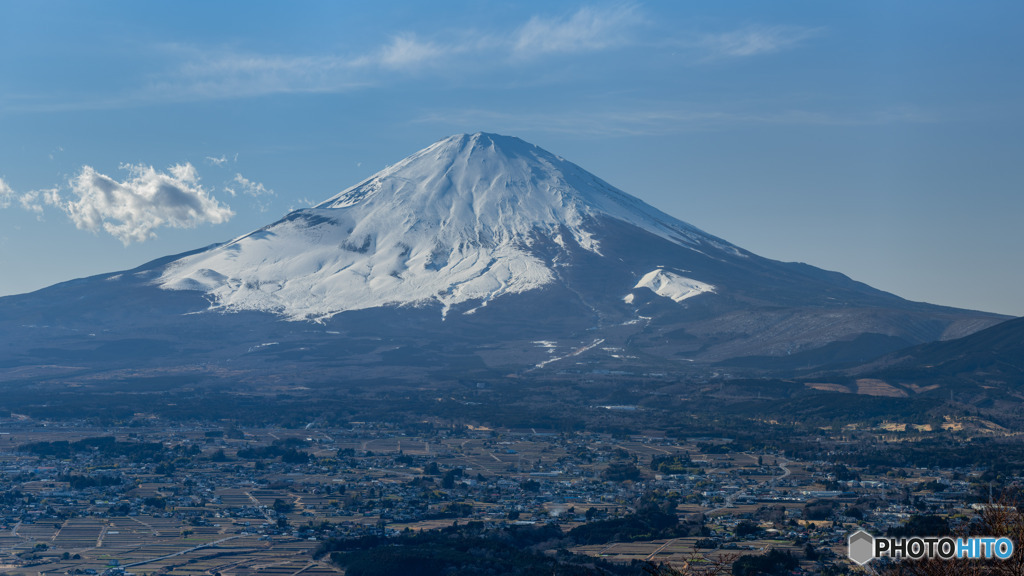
(0, 2), (821, 110)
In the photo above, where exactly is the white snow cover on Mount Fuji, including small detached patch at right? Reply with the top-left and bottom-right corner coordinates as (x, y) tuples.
(158, 133), (729, 320)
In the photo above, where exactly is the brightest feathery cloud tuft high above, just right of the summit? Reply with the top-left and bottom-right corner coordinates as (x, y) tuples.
(513, 4), (642, 55)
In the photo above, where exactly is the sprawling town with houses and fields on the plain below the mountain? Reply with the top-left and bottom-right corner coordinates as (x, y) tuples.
(0, 406), (1010, 576)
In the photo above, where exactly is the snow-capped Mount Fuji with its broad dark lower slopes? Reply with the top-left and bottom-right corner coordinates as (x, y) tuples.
(0, 133), (1005, 381)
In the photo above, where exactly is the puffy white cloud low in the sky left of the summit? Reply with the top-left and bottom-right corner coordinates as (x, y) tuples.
(61, 163), (234, 245)
